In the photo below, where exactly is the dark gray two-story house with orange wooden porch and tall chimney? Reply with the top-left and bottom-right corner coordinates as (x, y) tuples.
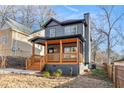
(27, 13), (91, 75)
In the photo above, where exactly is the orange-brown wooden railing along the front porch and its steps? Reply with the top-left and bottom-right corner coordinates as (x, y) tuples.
(26, 53), (84, 70)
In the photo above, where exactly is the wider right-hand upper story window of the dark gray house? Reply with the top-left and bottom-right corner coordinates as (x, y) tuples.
(65, 25), (77, 35)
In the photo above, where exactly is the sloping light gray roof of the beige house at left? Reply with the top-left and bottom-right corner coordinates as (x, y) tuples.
(2, 18), (33, 34)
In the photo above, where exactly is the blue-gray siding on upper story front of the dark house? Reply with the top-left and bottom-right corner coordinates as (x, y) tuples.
(45, 22), (83, 37)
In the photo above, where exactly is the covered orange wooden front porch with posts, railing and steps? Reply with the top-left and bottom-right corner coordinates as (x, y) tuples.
(26, 37), (84, 70)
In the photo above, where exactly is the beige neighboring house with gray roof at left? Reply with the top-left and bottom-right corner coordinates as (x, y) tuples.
(0, 18), (41, 68)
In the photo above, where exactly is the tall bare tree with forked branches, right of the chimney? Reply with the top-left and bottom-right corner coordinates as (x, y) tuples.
(99, 6), (124, 64)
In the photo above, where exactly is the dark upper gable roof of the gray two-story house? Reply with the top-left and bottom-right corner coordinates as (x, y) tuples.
(43, 18), (85, 28)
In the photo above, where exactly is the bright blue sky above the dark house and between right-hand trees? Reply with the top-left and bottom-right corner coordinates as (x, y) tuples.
(50, 5), (124, 54)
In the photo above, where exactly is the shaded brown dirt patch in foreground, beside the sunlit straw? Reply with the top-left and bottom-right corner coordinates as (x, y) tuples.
(59, 75), (113, 88)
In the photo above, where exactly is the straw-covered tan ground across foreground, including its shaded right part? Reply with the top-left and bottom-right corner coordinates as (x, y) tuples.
(0, 74), (111, 88)
